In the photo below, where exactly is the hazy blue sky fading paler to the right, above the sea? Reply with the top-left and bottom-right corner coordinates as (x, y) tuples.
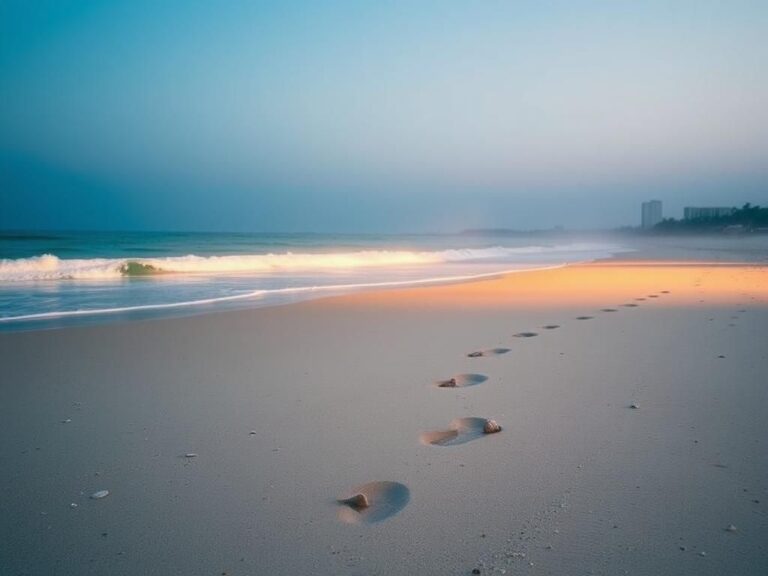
(0, 0), (768, 232)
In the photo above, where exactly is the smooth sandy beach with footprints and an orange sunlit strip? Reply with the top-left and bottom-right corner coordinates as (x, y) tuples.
(0, 262), (768, 576)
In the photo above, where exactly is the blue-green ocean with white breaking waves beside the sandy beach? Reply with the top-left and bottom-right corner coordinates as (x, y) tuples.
(0, 232), (626, 330)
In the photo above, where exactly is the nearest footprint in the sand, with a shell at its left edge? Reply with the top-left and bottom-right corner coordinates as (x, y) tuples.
(337, 481), (411, 524)
